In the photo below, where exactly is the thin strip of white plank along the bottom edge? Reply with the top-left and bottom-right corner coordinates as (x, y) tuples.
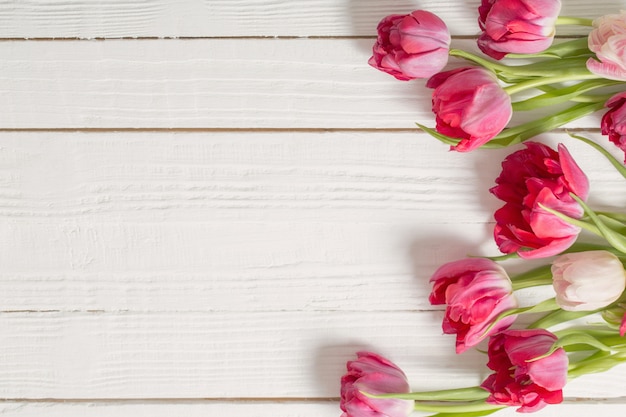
(0, 401), (624, 417)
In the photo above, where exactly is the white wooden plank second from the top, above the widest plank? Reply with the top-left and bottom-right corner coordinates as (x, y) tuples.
(0, 39), (599, 129)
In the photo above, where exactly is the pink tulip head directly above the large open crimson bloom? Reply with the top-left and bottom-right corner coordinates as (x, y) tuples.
(426, 67), (513, 152)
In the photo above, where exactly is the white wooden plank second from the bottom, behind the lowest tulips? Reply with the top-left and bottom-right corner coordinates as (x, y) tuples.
(0, 311), (626, 400)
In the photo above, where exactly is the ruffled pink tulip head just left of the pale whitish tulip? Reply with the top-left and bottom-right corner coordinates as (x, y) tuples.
(429, 258), (517, 353)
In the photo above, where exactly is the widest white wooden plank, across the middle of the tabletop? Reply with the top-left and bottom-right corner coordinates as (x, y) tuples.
(0, 132), (626, 311)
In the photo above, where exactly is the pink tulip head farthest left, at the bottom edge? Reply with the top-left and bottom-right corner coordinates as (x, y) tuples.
(339, 352), (415, 417)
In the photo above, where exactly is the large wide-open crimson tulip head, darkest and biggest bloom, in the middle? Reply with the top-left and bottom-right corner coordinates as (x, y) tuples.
(490, 142), (589, 259)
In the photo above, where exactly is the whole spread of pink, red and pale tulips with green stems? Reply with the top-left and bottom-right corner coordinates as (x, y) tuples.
(340, 0), (626, 417)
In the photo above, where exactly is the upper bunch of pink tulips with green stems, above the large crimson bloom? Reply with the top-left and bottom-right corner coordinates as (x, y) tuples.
(369, 0), (626, 156)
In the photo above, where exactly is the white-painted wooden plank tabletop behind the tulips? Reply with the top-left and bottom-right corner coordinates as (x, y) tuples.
(0, 0), (626, 417)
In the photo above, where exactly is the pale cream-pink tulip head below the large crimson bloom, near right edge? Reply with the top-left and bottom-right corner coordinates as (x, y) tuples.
(552, 250), (626, 311)
